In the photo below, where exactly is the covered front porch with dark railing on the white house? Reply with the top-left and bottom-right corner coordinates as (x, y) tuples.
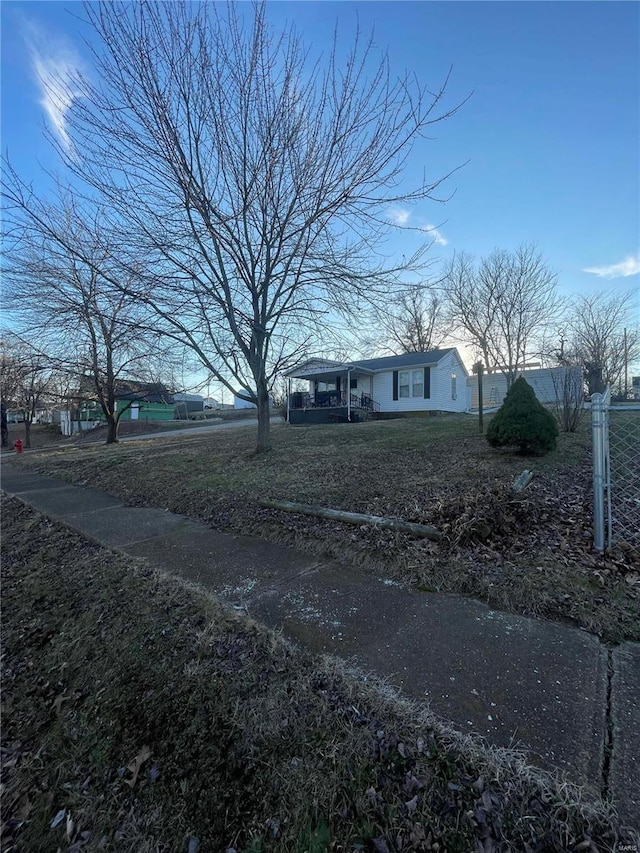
(287, 362), (380, 424)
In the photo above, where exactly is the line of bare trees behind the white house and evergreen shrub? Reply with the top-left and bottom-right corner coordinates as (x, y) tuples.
(364, 245), (640, 396)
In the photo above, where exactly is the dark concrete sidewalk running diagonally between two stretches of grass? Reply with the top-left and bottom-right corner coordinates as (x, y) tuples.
(2, 464), (640, 828)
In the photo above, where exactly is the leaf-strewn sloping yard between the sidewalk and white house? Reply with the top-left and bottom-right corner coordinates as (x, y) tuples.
(11, 415), (640, 642)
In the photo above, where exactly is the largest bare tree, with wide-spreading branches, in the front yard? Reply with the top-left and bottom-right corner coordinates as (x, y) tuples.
(50, 2), (455, 451)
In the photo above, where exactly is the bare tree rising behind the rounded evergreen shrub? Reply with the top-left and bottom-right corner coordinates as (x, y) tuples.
(443, 245), (561, 387)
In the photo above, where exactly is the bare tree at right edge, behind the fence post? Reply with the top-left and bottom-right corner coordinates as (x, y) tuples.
(558, 291), (640, 394)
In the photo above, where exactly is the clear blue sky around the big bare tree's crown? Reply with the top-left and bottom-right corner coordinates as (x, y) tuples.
(1, 0), (640, 302)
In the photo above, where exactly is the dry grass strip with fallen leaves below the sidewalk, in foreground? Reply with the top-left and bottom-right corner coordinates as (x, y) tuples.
(2, 500), (631, 853)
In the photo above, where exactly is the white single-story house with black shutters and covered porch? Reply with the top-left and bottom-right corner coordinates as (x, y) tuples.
(287, 347), (469, 424)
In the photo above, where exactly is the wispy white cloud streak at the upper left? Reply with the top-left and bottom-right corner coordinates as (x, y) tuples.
(25, 21), (84, 153)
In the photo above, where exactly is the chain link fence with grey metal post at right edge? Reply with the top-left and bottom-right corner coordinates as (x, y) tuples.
(591, 388), (640, 551)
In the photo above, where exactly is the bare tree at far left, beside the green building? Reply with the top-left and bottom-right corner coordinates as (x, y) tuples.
(2, 183), (170, 444)
